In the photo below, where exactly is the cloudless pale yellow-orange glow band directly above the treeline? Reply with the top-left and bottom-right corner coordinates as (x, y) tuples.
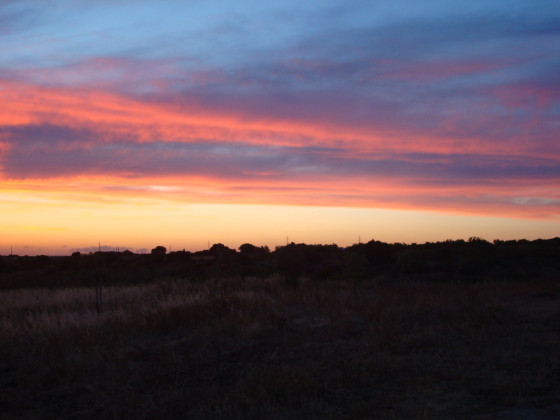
(0, 192), (560, 255)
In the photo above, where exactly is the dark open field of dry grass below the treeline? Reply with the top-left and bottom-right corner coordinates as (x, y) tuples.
(0, 276), (560, 419)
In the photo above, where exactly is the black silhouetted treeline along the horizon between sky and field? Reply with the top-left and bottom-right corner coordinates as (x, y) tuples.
(0, 237), (560, 289)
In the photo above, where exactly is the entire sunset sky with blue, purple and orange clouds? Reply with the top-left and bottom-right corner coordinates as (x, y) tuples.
(0, 0), (560, 255)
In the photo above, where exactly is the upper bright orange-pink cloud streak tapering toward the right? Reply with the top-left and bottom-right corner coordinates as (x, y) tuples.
(0, 81), (544, 155)
